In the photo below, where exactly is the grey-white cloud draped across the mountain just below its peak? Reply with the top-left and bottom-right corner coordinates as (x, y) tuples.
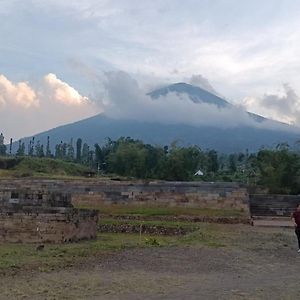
(103, 72), (255, 128)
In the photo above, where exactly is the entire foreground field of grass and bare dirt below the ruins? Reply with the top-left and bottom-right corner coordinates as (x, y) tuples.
(0, 223), (300, 300)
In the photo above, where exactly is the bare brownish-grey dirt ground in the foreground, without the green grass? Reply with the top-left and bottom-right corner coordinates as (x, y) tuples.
(0, 225), (300, 300)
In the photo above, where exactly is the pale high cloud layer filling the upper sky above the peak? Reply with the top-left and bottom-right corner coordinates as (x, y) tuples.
(0, 0), (300, 101)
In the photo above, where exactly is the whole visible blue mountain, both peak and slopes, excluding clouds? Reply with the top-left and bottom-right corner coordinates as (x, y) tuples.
(13, 83), (300, 152)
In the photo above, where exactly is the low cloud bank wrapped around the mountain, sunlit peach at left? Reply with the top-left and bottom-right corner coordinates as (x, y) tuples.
(0, 71), (300, 139)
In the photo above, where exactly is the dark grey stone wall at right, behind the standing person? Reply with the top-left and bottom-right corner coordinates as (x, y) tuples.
(250, 194), (300, 217)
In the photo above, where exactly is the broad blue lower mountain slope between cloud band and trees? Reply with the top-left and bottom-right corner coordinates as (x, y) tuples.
(14, 115), (300, 152)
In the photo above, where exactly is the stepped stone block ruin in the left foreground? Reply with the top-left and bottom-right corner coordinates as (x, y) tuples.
(0, 189), (98, 243)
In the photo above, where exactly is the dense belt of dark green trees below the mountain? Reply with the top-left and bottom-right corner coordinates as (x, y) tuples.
(0, 132), (300, 194)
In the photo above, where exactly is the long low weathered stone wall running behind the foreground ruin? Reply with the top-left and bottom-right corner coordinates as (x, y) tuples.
(0, 179), (249, 212)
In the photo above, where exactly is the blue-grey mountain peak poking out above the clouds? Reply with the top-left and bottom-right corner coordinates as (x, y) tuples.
(148, 82), (231, 107)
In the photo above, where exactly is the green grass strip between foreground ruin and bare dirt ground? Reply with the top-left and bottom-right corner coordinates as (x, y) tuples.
(0, 224), (230, 274)
